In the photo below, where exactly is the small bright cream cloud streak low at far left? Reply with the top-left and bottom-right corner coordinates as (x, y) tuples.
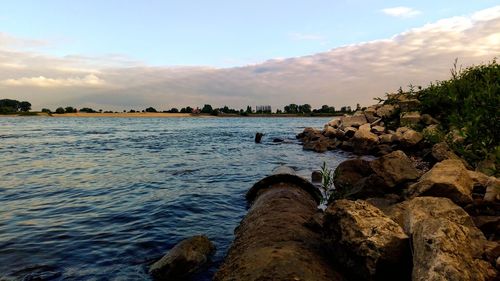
(0, 74), (106, 88)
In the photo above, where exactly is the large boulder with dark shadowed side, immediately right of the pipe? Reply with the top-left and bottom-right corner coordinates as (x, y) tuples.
(323, 199), (411, 280)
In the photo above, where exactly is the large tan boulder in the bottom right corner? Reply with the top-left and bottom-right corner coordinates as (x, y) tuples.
(412, 218), (495, 281)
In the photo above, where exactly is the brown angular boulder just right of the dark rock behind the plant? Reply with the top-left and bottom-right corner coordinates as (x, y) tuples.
(370, 150), (420, 188)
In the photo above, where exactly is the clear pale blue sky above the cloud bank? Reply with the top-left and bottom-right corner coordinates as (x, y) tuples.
(0, 0), (500, 67)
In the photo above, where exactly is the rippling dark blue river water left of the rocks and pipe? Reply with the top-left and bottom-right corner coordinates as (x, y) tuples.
(0, 117), (349, 280)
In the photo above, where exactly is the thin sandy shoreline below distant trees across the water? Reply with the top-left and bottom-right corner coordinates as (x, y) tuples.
(0, 112), (338, 118)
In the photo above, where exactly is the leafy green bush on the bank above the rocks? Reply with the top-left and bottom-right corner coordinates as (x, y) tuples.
(417, 60), (500, 165)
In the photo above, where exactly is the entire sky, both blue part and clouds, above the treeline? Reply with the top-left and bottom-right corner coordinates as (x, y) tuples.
(0, 0), (500, 110)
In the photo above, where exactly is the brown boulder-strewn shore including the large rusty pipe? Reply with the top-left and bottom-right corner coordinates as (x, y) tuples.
(152, 97), (500, 281)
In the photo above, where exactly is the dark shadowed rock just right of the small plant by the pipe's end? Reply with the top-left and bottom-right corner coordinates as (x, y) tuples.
(333, 159), (373, 193)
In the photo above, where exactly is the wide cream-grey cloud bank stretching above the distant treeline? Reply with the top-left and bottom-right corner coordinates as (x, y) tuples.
(0, 6), (500, 110)
